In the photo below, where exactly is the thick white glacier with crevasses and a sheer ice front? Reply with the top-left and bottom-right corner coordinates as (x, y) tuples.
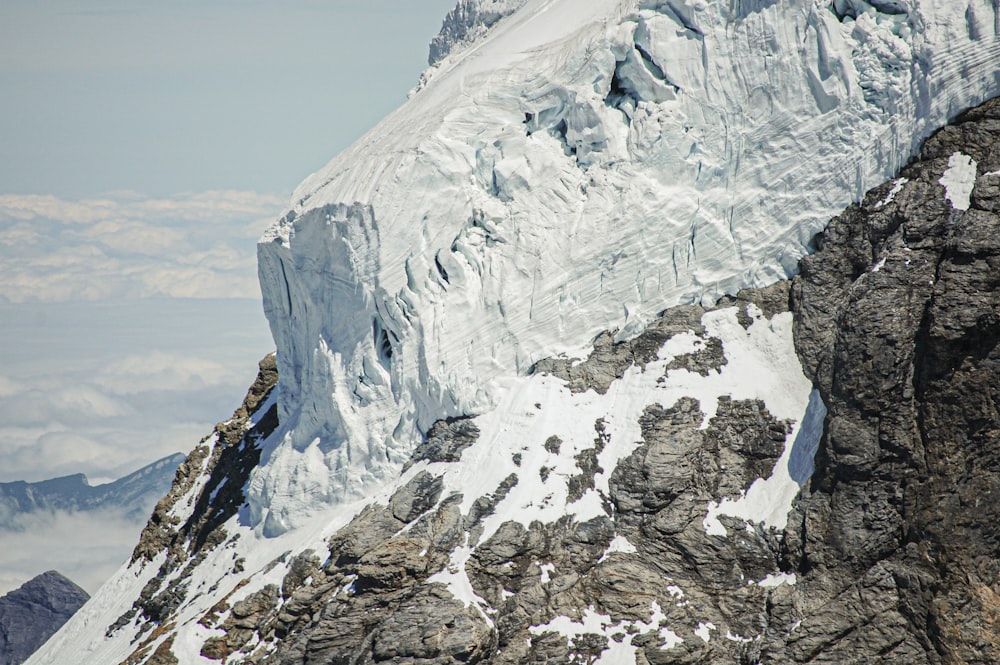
(246, 0), (1000, 536)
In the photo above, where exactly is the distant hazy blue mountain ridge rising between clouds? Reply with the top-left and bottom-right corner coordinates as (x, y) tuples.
(0, 453), (184, 530)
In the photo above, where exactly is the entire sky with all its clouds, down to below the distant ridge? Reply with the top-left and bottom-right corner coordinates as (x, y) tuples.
(0, 0), (454, 594)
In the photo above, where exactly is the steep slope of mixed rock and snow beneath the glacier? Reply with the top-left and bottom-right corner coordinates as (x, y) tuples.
(32, 101), (1000, 665)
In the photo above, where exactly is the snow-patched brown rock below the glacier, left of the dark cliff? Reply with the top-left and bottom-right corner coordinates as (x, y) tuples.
(184, 284), (790, 665)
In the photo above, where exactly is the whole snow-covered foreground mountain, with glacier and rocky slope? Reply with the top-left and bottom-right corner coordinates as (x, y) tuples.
(30, 0), (1000, 664)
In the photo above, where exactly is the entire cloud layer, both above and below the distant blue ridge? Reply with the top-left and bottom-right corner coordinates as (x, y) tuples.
(0, 192), (282, 594)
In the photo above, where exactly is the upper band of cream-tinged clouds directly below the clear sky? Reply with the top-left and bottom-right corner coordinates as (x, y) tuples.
(0, 191), (283, 302)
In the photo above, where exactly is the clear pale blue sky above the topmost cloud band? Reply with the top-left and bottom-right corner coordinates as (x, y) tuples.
(0, 0), (454, 197)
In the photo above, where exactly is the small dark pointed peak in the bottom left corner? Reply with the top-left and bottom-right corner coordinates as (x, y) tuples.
(0, 570), (90, 665)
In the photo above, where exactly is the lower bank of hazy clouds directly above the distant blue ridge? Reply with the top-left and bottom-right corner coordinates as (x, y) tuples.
(0, 299), (273, 482)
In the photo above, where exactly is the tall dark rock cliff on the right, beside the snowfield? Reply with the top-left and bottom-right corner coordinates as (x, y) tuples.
(765, 100), (1000, 663)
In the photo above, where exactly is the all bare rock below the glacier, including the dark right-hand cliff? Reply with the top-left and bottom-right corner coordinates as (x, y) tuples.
(236, 102), (1000, 665)
